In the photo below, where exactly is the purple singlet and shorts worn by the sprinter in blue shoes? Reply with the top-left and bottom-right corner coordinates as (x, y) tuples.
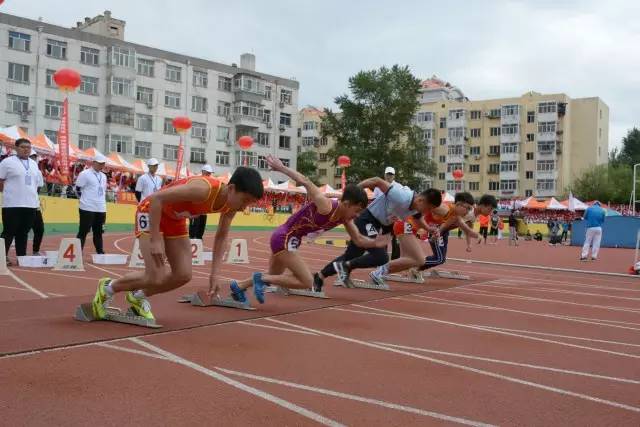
(271, 200), (343, 254)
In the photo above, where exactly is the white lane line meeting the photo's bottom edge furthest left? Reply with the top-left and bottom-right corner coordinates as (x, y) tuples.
(130, 338), (343, 427)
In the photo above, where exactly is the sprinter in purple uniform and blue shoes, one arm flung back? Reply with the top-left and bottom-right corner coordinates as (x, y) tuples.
(230, 156), (389, 303)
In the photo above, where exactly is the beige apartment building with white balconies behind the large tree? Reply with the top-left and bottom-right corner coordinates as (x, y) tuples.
(299, 76), (609, 199)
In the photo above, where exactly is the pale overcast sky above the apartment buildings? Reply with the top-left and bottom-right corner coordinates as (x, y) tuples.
(0, 0), (640, 148)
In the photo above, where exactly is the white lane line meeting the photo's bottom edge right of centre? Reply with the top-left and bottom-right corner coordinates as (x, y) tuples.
(216, 368), (492, 426)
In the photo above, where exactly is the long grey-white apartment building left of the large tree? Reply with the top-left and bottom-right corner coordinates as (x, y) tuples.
(0, 11), (299, 181)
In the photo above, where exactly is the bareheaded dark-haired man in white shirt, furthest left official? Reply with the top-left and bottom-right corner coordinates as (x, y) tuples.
(0, 138), (40, 256)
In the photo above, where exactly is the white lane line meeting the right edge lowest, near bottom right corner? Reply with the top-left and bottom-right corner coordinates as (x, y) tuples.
(268, 319), (640, 413)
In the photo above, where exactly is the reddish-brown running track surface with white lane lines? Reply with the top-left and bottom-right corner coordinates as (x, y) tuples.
(0, 232), (640, 426)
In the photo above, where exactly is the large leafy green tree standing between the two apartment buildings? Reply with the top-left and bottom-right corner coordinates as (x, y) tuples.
(322, 65), (436, 189)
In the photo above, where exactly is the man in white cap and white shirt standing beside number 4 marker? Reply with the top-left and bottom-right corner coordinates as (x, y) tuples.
(76, 154), (107, 254)
